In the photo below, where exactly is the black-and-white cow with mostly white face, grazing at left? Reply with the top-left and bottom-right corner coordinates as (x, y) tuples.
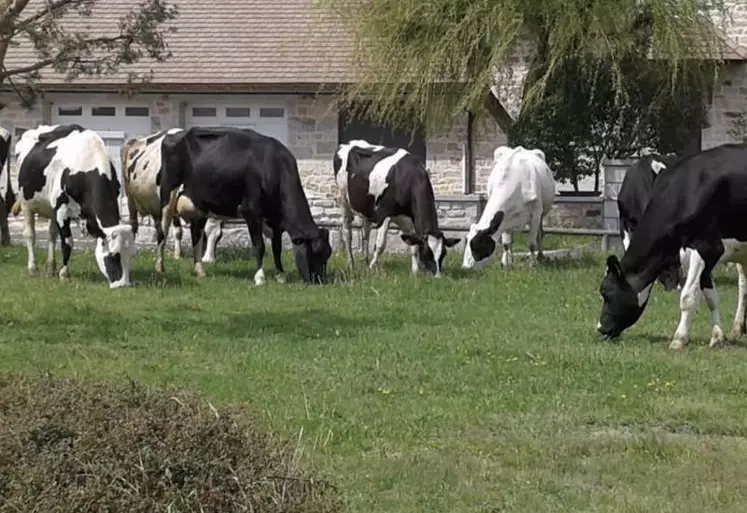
(13, 125), (136, 288)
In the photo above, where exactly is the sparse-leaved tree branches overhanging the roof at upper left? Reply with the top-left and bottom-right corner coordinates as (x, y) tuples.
(0, 0), (178, 245)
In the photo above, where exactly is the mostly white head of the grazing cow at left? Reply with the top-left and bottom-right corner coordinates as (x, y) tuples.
(94, 224), (137, 289)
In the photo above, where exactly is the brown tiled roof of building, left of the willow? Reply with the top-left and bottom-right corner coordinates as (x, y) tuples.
(5, 0), (352, 87)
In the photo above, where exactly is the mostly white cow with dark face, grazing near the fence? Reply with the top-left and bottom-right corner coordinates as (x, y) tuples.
(462, 146), (555, 269)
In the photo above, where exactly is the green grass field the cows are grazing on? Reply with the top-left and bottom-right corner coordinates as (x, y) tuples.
(0, 236), (747, 513)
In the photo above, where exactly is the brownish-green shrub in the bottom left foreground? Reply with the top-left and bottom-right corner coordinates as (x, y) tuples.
(0, 373), (340, 513)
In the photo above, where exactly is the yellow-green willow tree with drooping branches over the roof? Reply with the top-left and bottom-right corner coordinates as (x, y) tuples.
(317, 0), (727, 131)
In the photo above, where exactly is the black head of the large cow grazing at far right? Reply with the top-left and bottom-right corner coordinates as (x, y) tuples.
(597, 255), (645, 338)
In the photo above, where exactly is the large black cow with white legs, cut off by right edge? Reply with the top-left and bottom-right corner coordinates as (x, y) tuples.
(597, 144), (747, 349)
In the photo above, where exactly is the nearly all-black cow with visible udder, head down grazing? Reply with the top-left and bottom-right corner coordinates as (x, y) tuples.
(160, 127), (332, 285)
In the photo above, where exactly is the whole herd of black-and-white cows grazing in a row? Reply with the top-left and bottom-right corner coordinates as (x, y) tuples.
(0, 125), (747, 349)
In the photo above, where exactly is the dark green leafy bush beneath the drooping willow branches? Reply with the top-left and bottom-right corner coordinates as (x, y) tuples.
(508, 51), (712, 190)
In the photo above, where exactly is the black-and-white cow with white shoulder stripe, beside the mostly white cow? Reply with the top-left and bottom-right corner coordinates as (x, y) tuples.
(333, 140), (459, 276)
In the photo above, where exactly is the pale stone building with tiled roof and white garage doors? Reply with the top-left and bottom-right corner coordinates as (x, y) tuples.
(0, 0), (747, 249)
